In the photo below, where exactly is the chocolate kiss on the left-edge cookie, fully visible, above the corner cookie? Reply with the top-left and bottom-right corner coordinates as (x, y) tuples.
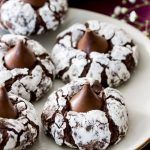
(4, 41), (36, 69)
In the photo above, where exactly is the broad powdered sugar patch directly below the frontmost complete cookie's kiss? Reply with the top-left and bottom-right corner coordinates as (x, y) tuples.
(67, 110), (111, 149)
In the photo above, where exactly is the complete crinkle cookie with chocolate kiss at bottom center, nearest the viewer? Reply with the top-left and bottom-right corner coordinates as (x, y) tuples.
(41, 78), (128, 150)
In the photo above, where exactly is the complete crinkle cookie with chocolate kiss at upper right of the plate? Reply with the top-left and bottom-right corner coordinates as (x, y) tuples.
(52, 20), (138, 87)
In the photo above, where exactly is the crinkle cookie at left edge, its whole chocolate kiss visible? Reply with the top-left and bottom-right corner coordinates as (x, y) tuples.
(0, 34), (55, 101)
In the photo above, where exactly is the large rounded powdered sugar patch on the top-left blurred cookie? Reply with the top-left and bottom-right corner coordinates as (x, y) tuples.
(1, 0), (36, 35)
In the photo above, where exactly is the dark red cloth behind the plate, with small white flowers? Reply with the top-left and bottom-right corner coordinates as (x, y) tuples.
(69, 0), (150, 38)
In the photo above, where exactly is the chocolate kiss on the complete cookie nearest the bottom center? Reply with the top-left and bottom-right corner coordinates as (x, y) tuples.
(70, 83), (103, 112)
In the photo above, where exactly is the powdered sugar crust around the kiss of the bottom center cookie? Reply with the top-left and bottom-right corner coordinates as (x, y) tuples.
(42, 78), (128, 149)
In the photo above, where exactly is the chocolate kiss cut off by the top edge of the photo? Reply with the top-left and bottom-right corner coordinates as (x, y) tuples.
(23, 0), (46, 8)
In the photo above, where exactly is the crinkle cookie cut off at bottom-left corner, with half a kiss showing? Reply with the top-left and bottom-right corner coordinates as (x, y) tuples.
(0, 87), (39, 150)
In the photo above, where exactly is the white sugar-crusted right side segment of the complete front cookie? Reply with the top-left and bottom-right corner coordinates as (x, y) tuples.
(104, 88), (128, 143)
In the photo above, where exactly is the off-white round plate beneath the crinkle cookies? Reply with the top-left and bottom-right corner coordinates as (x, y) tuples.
(1, 9), (150, 150)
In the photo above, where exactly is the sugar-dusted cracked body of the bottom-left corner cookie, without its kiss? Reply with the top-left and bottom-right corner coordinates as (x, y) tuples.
(0, 94), (39, 150)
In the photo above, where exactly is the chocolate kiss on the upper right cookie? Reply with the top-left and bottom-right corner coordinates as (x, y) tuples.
(77, 29), (109, 54)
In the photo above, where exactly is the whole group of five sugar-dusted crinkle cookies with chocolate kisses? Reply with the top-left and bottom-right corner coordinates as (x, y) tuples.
(0, 0), (138, 150)
